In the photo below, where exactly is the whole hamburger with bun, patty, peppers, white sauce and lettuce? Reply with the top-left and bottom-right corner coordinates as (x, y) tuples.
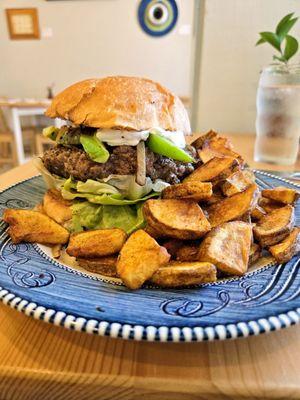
(38, 76), (197, 233)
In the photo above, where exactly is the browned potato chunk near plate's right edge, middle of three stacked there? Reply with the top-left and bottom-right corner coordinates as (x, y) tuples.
(253, 205), (295, 247)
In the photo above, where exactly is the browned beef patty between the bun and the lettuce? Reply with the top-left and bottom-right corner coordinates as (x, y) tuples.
(42, 145), (196, 184)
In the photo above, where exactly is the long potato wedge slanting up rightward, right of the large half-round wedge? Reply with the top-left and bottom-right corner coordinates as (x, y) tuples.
(206, 184), (259, 227)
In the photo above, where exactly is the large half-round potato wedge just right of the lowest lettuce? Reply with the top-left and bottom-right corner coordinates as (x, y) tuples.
(143, 199), (210, 240)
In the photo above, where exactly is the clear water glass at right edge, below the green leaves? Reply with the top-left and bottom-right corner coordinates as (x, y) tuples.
(254, 64), (300, 165)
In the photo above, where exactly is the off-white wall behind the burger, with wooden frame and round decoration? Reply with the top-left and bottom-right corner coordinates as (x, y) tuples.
(0, 0), (193, 97)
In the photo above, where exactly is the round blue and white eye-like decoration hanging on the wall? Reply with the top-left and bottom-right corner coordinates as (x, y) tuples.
(138, 0), (178, 36)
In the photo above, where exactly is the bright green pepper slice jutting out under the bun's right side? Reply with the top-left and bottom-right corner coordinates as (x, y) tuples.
(147, 133), (195, 163)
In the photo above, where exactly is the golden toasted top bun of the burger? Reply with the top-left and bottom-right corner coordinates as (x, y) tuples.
(45, 76), (191, 134)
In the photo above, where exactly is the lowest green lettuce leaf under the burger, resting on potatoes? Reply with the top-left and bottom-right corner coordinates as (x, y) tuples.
(71, 201), (145, 234)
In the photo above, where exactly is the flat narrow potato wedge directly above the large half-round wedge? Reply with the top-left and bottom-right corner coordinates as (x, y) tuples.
(162, 182), (212, 202)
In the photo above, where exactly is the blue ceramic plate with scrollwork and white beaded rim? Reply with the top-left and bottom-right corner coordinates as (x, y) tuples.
(0, 171), (300, 342)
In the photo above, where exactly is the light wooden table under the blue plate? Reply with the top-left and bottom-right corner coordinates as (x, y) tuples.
(0, 135), (300, 400)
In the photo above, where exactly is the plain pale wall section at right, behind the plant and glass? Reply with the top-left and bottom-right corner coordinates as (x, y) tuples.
(196, 0), (300, 133)
